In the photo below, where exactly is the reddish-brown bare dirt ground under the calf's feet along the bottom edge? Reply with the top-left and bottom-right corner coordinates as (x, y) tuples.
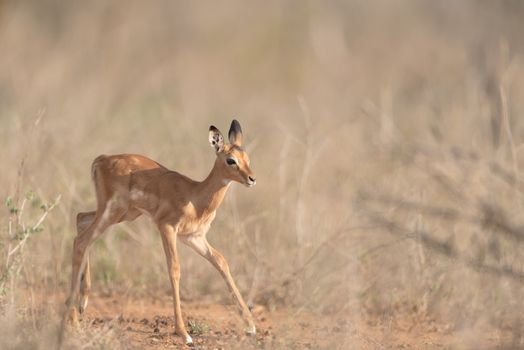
(60, 295), (515, 349)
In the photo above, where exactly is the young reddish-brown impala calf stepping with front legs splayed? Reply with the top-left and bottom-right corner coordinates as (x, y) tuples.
(68, 120), (256, 344)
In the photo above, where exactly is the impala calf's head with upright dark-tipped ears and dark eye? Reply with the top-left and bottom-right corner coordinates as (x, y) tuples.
(209, 120), (256, 187)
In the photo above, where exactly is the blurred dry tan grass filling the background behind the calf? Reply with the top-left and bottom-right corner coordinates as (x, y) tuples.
(0, 0), (524, 344)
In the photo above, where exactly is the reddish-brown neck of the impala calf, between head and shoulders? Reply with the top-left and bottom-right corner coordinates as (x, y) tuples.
(198, 159), (231, 213)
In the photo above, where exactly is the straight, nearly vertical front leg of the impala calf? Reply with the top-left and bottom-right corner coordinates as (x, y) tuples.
(160, 225), (193, 345)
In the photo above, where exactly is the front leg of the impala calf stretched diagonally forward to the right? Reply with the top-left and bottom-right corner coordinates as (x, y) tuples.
(182, 236), (256, 335)
